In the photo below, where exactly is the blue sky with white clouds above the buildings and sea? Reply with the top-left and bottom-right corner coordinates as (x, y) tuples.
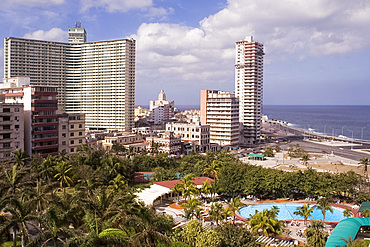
(0, 0), (370, 105)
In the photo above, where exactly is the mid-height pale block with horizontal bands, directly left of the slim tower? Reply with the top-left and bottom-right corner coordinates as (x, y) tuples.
(200, 90), (239, 146)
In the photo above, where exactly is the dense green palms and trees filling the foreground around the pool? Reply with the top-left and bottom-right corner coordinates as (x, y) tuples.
(0, 148), (370, 246)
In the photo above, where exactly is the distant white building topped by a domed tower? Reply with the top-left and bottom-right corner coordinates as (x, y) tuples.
(150, 90), (175, 124)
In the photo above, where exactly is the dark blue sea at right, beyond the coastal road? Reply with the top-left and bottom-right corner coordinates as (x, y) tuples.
(262, 105), (370, 141)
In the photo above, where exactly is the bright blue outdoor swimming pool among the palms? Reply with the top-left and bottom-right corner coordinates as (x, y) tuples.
(239, 203), (347, 221)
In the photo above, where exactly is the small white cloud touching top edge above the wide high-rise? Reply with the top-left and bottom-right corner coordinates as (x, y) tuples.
(81, 0), (153, 12)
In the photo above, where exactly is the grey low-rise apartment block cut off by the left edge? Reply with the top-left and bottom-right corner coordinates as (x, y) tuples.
(0, 103), (24, 161)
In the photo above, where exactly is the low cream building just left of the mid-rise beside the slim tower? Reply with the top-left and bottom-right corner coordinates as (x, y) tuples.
(166, 122), (210, 153)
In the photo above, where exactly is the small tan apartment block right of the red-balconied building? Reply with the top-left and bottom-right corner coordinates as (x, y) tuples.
(58, 113), (86, 154)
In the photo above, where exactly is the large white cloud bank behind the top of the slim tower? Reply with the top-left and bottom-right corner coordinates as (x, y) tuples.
(133, 0), (370, 87)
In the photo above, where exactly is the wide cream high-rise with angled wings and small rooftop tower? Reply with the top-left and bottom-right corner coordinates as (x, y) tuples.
(4, 24), (135, 131)
